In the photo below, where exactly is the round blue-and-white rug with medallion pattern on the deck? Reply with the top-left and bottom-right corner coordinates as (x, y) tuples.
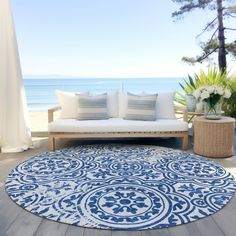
(6, 145), (236, 230)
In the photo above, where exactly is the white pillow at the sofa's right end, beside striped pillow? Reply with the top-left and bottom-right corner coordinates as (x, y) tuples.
(156, 92), (176, 119)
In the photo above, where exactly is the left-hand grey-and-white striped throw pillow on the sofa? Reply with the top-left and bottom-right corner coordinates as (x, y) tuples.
(78, 93), (109, 120)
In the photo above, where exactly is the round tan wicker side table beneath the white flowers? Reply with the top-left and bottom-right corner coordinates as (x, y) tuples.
(193, 116), (235, 157)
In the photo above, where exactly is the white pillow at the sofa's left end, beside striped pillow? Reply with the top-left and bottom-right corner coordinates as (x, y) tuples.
(56, 90), (88, 119)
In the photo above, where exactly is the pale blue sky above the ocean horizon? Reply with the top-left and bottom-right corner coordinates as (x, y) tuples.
(12, 0), (236, 78)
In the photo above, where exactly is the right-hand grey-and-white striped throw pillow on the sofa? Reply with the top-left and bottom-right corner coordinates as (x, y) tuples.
(125, 93), (157, 121)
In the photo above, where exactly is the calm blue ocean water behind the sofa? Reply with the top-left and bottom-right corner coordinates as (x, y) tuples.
(23, 78), (183, 111)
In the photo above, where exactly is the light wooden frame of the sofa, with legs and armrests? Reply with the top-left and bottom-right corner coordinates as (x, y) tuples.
(48, 106), (188, 151)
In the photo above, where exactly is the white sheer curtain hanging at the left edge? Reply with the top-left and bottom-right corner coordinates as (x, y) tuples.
(0, 0), (32, 152)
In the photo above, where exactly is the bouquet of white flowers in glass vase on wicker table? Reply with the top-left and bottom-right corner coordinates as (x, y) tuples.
(193, 85), (231, 118)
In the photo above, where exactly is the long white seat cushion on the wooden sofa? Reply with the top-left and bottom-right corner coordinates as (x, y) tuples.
(48, 118), (188, 133)
